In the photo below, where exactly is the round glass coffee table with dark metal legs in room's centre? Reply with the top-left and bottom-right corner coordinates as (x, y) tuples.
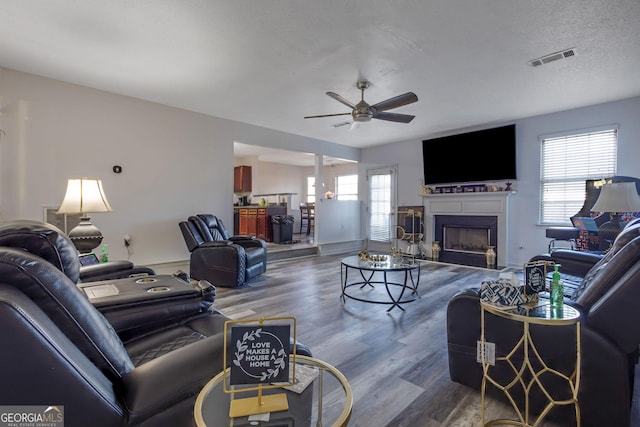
(340, 255), (420, 311)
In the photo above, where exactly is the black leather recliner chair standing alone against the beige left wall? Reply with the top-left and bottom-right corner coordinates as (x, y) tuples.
(178, 214), (267, 288)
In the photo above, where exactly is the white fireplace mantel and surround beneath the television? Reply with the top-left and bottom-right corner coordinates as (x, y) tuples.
(422, 191), (516, 267)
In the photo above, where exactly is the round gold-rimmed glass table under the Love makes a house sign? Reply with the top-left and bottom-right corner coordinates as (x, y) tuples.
(194, 356), (353, 427)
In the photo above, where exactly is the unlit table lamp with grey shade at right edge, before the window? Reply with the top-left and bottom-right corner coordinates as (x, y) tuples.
(591, 182), (640, 249)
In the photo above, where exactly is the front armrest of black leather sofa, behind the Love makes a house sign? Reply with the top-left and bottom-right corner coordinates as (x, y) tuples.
(122, 333), (224, 424)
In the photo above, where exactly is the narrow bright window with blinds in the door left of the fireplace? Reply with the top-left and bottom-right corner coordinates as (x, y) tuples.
(368, 169), (396, 242)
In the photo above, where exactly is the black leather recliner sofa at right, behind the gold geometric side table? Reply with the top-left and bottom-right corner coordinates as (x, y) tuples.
(447, 222), (640, 427)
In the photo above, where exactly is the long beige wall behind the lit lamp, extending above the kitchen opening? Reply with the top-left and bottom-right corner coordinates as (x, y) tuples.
(0, 69), (359, 264)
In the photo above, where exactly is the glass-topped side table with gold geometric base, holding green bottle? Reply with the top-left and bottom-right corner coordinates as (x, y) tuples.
(480, 298), (580, 427)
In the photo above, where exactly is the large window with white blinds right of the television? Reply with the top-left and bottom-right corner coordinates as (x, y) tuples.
(540, 129), (618, 224)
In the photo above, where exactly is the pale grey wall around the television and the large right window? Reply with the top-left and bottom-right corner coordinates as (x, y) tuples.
(360, 97), (640, 265)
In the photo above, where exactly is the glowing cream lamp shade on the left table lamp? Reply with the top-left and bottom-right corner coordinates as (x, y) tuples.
(58, 178), (113, 214)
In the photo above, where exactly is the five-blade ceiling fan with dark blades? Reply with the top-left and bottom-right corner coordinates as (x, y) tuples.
(305, 80), (418, 124)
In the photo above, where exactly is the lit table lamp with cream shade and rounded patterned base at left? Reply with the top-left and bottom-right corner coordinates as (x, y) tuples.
(58, 178), (113, 253)
